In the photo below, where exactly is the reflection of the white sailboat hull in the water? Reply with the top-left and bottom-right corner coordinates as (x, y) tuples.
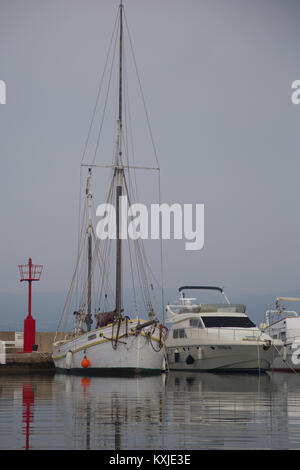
(57, 376), (165, 450)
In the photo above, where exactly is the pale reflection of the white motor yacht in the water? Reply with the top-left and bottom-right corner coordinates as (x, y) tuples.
(164, 373), (286, 449)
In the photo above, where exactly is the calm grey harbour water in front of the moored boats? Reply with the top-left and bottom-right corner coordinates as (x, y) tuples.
(0, 372), (300, 450)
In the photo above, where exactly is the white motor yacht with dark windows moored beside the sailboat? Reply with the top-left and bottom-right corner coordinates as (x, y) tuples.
(166, 286), (283, 371)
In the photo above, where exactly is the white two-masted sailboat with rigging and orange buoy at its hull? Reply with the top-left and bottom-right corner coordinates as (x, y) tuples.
(52, 1), (167, 375)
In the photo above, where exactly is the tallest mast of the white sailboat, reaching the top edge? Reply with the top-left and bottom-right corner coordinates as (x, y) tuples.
(115, 0), (124, 316)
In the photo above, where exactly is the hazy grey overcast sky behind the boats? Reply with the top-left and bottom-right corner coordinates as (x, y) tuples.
(0, 0), (300, 304)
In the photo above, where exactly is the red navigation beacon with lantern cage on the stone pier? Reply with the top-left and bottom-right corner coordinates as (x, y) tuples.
(19, 258), (43, 353)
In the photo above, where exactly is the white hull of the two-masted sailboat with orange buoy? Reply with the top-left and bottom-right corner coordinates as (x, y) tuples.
(52, 320), (165, 375)
